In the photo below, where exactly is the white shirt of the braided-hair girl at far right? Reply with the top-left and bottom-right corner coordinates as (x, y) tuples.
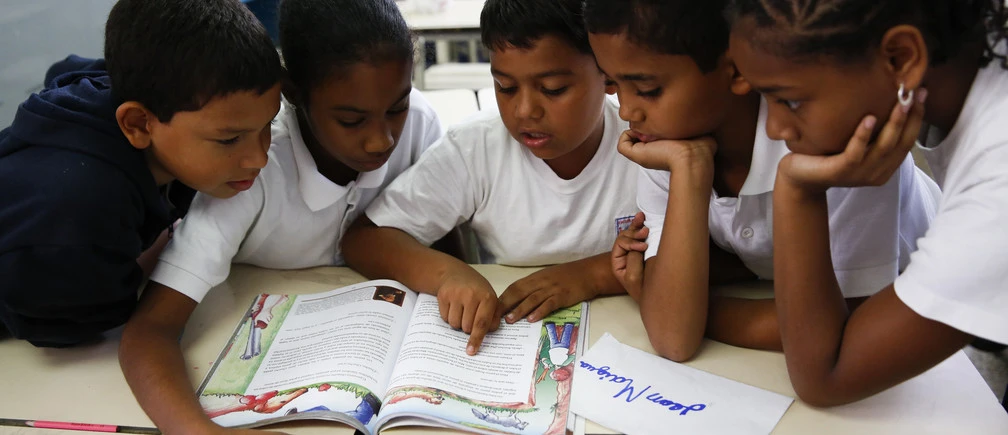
(894, 60), (1008, 343)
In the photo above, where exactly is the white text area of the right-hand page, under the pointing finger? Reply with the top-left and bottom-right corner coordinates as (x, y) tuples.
(389, 294), (542, 403)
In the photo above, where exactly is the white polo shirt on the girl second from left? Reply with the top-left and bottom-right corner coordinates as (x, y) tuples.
(150, 90), (442, 302)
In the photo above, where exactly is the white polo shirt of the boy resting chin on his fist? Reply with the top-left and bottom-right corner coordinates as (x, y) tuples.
(637, 100), (940, 297)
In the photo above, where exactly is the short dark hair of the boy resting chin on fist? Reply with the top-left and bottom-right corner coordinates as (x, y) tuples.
(585, 0), (731, 73)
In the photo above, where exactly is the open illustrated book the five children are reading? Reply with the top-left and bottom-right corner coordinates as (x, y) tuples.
(198, 280), (588, 434)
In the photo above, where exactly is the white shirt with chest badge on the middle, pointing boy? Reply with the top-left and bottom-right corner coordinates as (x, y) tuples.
(367, 100), (637, 266)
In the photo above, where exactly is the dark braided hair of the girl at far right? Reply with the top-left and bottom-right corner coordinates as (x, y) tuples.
(726, 0), (1008, 65)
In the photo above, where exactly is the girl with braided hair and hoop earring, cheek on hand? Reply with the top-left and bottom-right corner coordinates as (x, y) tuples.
(727, 0), (1008, 406)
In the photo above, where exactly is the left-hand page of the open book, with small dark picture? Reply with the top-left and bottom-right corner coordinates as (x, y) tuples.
(194, 281), (416, 426)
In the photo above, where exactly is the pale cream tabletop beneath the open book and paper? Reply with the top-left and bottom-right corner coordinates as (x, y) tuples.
(0, 265), (1008, 435)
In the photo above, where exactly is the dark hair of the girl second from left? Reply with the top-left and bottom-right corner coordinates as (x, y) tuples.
(279, 0), (413, 99)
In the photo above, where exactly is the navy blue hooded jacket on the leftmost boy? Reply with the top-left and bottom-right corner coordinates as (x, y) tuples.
(0, 55), (192, 346)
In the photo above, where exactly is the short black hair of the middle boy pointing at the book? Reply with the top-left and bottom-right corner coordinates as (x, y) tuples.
(480, 0), (592, 54)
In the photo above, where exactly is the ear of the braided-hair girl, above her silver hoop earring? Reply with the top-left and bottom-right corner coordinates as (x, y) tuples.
(879, 24), (929, 90)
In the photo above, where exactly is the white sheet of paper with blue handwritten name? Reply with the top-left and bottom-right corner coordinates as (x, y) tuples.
(571, 333), (794, 434)
